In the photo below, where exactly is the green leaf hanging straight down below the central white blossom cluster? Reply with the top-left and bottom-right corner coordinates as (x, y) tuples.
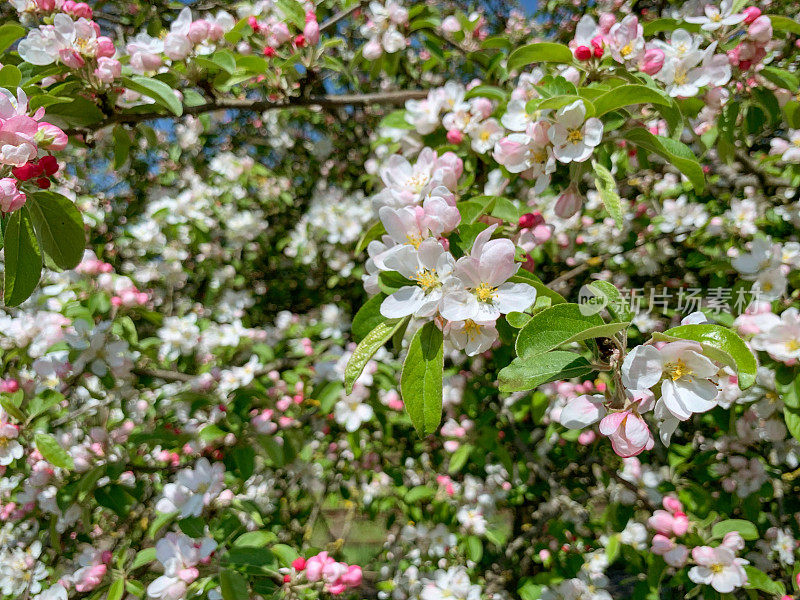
(400, 321), (444, 435)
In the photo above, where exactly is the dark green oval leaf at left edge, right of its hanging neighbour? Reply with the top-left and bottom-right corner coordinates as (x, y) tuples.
(29, 191), (86, 269)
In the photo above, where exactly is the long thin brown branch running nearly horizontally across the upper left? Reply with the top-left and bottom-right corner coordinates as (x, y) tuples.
(66, 90), (428, 135)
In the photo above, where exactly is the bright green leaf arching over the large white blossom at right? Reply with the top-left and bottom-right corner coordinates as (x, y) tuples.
(653, 325), (758, 390)
